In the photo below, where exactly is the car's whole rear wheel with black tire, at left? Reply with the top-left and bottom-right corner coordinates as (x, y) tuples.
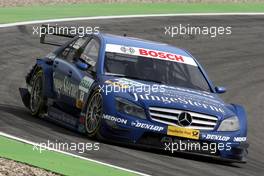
(29, 70), (46, 117)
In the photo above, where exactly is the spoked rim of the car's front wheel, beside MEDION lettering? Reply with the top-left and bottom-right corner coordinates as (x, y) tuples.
(85, 92), (102, 134)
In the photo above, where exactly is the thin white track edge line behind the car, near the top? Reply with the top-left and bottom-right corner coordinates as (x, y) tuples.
(0, 12), (264, 28)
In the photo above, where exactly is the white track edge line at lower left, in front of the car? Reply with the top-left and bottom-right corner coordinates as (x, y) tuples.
(0, 131), (150, 176)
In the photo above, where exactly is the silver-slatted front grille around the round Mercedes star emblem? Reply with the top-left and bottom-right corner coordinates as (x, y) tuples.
(149, 107), (217, 130)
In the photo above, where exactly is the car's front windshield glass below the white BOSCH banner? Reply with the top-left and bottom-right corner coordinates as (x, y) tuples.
(104, 49), (210, 91)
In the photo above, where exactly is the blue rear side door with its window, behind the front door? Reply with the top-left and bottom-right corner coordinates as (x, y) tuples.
(53, 37), (89, 109)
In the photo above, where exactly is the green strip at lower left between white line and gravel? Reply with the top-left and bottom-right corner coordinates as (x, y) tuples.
(0, 136), (139, 176)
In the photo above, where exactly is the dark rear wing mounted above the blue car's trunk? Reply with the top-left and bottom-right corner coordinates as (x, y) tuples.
(40, 24), (76, 46)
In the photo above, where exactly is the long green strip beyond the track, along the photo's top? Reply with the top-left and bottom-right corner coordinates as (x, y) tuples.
(0, 3), (264, 23)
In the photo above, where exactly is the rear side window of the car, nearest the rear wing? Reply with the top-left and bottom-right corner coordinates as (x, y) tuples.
(59, 37), (87, 62)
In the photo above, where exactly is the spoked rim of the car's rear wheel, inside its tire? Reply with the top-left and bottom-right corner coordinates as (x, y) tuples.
(30, 77), (42, 112)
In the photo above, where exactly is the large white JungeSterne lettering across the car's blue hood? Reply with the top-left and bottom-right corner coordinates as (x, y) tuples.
(133, 93), (225, 114)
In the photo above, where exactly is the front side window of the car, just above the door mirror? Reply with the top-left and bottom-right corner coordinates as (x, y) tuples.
(80, 39), (99, 67)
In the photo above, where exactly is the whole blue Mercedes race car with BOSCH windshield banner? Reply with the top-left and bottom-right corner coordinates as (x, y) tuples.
(19, 24), (248, 162)
